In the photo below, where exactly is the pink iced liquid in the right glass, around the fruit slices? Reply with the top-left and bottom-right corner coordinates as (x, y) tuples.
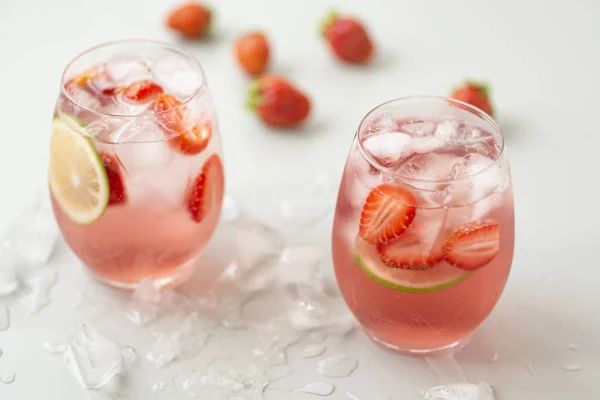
(333, 117), (514, 352)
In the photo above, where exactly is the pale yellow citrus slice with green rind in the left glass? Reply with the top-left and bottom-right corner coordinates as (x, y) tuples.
(50, 117), (109, 224)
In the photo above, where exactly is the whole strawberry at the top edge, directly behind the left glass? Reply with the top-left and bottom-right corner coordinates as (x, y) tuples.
(167, 2), (212, 39)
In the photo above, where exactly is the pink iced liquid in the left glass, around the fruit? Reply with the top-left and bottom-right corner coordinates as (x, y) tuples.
(52, 49), (224, 288)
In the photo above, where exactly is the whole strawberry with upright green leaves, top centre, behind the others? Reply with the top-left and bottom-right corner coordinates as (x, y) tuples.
(321, 12), (374, 63)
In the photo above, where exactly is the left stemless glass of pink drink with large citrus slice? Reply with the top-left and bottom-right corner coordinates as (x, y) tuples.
(49, 41), (224, 288)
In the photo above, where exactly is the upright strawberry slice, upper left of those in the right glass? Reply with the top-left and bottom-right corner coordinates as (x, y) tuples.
(359, 183), (416, 244)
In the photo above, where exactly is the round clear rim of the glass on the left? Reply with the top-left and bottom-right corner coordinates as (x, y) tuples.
(60, 39), (206, 119)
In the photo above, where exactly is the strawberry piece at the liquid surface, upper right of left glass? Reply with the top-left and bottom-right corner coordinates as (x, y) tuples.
(153, 93), (212, 155)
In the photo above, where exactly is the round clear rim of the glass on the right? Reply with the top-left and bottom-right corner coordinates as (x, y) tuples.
(356, 95), (506, 184)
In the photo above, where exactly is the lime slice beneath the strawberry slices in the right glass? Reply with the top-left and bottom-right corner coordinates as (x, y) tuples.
(354, 239), (473, 293)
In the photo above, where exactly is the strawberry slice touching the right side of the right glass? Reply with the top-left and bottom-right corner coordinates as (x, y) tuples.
(444, 220), (500, 270)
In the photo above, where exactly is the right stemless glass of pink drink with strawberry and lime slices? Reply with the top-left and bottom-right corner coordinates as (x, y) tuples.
(333, 97), (514, 354)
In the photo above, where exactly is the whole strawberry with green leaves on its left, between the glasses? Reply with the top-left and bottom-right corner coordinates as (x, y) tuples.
(246, 75), (310, 128)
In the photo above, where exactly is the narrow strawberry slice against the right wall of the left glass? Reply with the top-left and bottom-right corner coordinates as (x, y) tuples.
(187, 154), (225, 222)
